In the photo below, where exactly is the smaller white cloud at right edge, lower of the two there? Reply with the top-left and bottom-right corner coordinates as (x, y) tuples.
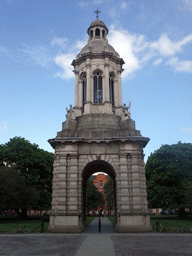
(166, 57), (192, 73)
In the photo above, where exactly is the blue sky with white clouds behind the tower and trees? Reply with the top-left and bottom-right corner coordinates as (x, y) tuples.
(0, 0), (192, 161)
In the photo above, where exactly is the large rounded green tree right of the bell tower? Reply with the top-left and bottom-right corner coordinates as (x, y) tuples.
(145, 142), (192, 212)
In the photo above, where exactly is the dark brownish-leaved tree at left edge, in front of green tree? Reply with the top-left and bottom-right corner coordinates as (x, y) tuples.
(0, 166), (38, 218)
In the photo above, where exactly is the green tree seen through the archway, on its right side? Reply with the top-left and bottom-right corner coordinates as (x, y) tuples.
(104, 177), (115, 213)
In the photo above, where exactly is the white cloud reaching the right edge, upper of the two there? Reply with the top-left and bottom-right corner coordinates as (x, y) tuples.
(151, 34), (192, 56)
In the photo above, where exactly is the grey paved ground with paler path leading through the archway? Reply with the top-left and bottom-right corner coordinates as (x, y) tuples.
(0, 217), (192, 256)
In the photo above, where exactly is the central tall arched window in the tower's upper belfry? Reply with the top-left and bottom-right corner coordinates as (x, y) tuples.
(93, 72), (103, 103)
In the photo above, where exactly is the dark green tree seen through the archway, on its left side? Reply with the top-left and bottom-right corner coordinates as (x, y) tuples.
(87, 179), (104, 211)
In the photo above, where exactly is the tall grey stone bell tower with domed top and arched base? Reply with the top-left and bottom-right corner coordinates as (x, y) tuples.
(49, 14), (151, 232)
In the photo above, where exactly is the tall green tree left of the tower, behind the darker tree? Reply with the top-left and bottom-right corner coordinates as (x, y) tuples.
(0, 137), (53, 215)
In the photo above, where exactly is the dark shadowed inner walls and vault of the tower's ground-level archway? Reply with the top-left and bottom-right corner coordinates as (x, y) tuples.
(80, 160), (117, 228)
